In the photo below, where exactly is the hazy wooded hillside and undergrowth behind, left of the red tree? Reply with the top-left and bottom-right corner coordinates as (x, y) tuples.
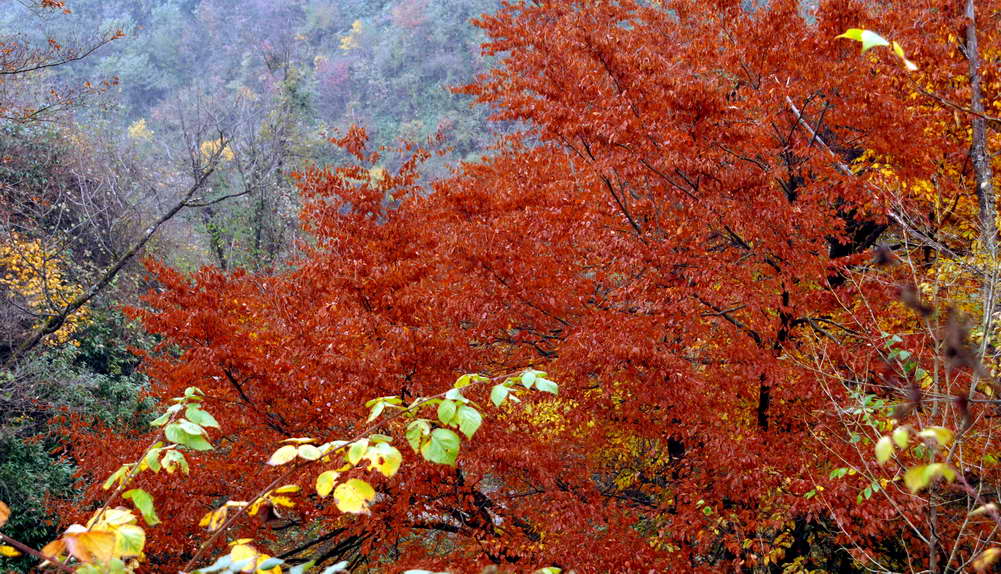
(0, 0), (497, 569)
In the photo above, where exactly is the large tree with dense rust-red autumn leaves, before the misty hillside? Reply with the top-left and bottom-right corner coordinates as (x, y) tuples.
(68, 0), (994, 572)
